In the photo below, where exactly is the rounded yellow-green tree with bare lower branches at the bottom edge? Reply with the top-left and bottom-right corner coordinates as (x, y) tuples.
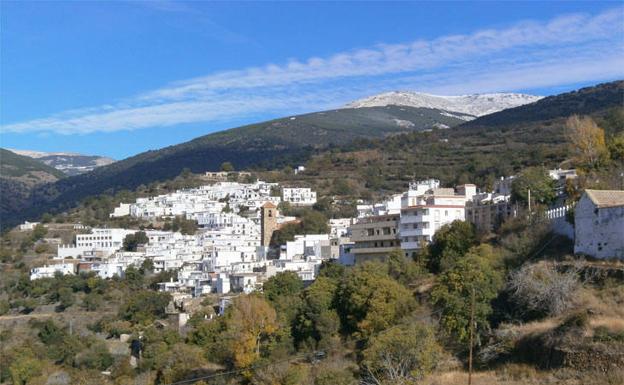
(362, 322), (442, 384)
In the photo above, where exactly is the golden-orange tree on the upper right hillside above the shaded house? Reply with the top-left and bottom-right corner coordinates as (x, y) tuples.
(565, 115), (609, 169)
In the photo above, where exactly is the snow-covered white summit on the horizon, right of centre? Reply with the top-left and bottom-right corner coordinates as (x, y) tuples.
(344, 91), (542, 120)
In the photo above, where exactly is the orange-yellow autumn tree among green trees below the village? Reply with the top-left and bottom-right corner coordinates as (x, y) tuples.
(227, 295), (279, 368)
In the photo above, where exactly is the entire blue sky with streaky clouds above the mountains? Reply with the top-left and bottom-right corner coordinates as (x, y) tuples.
(0, 1), (624, 159)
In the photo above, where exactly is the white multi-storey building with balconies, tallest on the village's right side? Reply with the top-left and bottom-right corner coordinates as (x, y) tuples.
(399, 180), (477, 255)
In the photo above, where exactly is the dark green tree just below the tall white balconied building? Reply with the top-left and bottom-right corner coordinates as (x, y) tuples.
(427, 220), (477, 273)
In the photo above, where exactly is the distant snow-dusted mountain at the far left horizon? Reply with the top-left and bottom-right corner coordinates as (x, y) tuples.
(9, 149), (115, 175)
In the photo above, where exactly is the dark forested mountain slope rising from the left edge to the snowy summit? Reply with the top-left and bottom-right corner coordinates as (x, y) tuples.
(2, 106), (463, 228)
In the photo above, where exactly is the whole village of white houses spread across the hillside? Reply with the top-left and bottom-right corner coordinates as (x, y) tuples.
(20, 167), (624, 322)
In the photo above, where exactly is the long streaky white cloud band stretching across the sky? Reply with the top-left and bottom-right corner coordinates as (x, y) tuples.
(3, 7), (624, 134)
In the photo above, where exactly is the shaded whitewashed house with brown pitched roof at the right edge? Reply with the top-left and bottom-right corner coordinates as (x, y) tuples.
(574, 190), (624, 259)
